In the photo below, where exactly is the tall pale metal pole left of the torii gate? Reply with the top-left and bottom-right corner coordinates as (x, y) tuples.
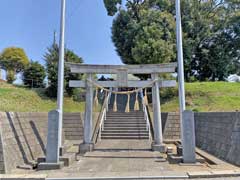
(57, 0), (66, 148)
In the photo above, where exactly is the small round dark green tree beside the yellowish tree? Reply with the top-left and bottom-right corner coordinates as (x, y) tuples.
(23, 62), (46, 88)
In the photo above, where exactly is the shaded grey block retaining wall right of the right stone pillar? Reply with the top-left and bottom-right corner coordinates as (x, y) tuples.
(195, 112), (240, 165)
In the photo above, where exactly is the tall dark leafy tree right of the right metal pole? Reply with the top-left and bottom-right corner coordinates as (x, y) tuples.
(182, 0), (239, 81)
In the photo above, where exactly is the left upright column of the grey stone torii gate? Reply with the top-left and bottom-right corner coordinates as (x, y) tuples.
(79, 74), (94, 154)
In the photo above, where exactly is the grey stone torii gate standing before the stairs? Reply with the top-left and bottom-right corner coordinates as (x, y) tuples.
(68, 63), (177, 152)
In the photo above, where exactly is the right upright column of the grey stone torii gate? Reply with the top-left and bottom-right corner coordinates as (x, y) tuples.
(151, 74), (166, 152)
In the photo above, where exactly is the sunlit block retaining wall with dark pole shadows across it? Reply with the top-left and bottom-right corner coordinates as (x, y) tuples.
(0, 113), (47, 173)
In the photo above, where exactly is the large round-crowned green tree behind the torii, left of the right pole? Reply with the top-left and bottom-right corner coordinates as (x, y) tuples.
(104, 0), (175, 67)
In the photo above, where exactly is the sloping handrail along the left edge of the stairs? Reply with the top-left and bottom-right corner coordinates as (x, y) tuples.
(92, 93), (111, 143)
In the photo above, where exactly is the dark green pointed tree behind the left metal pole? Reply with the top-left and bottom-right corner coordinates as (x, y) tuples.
(44, 43), (83, 97)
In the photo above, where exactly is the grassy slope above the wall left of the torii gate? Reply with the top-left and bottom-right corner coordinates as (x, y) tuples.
(0, 82), (84, 112)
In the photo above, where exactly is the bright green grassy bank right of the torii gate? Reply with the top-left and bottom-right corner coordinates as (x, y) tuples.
(161, 82), (240, 112)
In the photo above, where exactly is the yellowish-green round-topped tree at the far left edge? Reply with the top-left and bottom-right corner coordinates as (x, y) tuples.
(0, 47), (29, 83)
